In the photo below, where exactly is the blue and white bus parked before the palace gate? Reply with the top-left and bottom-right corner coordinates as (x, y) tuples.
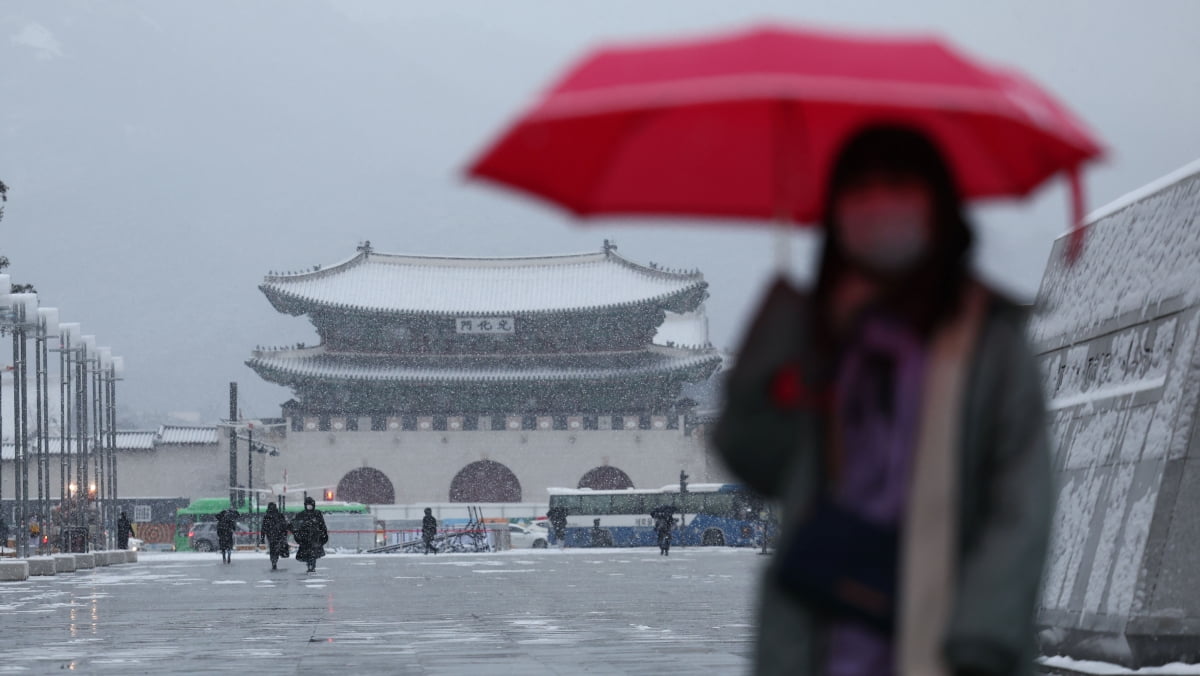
(547, 484), (764, 546)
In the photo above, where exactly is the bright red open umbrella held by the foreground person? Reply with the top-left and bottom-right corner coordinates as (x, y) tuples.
(469, 28), (1100, 254)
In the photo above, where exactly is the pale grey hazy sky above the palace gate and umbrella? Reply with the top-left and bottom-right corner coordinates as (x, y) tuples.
(0, 0), (1200, 420)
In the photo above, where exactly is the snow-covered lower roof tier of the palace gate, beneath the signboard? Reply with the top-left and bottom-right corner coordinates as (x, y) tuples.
(246, 346), (721, 383)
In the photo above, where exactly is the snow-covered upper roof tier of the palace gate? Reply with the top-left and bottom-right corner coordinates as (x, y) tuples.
(259, 246), (708, 316)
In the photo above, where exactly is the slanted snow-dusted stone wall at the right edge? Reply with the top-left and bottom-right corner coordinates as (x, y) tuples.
(1030, 163), (1200, 664)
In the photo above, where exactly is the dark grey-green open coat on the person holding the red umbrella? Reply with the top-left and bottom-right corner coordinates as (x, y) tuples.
(713, 276), (1052, 676)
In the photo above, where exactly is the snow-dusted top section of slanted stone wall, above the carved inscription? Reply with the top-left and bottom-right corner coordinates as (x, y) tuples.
(1030, 162), (1200, 343)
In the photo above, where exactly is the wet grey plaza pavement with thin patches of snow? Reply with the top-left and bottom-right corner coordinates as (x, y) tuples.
(0, 549), (763, 675)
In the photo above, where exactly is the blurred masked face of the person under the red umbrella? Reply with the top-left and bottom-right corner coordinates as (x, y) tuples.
(838, 186), (931, 275)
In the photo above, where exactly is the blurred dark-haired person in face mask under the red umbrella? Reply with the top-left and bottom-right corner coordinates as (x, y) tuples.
(714, 127), (1052, 676)
